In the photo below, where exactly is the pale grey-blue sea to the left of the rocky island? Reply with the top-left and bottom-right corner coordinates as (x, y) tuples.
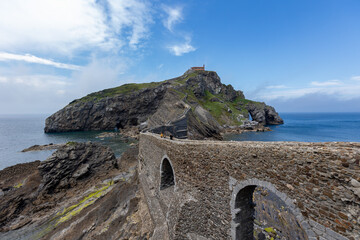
(0, 115), (135, 170)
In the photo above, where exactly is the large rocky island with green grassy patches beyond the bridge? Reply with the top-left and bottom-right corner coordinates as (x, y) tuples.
(45, 71), (283, 139)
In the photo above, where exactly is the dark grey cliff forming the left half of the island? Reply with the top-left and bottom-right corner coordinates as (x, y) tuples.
(45, 83), (168, 133)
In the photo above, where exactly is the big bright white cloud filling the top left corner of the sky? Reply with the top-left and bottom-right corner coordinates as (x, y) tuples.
(0, 0), (151, 54)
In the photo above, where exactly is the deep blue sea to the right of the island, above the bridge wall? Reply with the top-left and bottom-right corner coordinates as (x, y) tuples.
(226, 113), (360, 142)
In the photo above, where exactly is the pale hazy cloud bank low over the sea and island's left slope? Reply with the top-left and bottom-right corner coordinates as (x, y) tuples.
(0, 57), (132, 113)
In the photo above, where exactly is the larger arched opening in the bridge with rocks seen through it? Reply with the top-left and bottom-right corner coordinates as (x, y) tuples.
(231, 180), (308, 240)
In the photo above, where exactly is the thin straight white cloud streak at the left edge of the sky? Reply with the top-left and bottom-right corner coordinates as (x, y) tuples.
(0, 52), (81, 70)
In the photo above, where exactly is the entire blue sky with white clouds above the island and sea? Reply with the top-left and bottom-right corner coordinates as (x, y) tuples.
(0, 0), (360, 114)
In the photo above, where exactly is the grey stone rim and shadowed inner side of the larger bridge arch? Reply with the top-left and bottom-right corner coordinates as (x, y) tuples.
(230, 177), (314, 240)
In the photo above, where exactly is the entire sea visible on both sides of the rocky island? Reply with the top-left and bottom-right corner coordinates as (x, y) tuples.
(0, 113), (360, 170)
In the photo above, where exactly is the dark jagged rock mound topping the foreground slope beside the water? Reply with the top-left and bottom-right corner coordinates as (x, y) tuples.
(38, 142), (117, 193)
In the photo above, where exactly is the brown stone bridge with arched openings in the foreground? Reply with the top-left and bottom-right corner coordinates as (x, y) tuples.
(139, 133), (360, 240)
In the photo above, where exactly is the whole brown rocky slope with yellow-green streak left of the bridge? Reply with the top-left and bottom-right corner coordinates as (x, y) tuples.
(0, 143), (153, 240)
